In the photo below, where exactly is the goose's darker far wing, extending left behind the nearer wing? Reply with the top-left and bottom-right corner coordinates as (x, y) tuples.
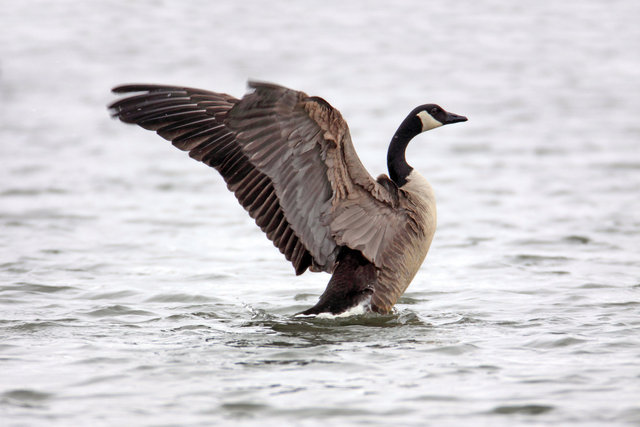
(109, 85), (312, 274)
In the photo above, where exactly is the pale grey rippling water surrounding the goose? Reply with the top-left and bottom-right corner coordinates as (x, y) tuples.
(0, 0), (640, 426)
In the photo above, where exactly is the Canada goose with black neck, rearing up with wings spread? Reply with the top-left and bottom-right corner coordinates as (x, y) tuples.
(109, 82), (467, 315)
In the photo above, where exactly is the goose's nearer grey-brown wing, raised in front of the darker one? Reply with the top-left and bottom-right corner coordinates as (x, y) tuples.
(228, 82), (406, 271)
